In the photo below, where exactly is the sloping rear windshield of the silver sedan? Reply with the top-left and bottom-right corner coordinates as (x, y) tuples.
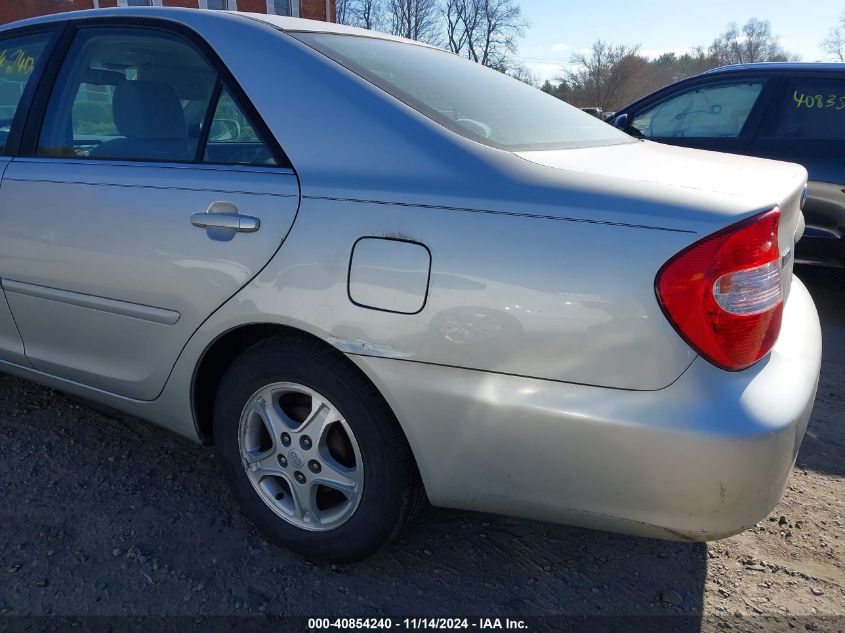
(292, 32), (632, 151)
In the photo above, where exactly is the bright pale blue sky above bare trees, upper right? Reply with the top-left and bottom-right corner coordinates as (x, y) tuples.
(518, 0), (845, 79)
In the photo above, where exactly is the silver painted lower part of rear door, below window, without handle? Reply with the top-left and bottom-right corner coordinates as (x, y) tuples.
(0, 159), (299, 400)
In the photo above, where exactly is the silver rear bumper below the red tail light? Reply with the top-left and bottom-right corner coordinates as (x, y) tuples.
(353, 279), (821, 540)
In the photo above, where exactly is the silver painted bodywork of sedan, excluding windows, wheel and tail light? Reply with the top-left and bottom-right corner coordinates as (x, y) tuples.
(0, 8), (821, 539)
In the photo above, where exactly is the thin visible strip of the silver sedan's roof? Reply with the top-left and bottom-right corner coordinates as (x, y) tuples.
(0, 7), (434, 48)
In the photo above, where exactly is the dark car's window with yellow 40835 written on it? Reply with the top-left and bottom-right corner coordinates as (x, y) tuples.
(775, 78), (845, 141)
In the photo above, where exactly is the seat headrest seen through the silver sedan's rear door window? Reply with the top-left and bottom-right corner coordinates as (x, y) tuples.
(112, 81), (188, 139)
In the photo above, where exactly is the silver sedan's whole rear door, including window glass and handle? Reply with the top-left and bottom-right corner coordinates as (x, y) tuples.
(0, 18), (299, 400)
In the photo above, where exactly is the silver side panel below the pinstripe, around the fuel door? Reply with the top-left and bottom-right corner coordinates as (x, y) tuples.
(236, 198), (694, 390)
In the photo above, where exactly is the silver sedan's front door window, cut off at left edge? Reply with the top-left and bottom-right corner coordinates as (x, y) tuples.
(0, 34), (50, 152)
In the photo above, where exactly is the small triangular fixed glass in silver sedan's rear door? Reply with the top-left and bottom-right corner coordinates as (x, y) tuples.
(203, 90), (277, 166)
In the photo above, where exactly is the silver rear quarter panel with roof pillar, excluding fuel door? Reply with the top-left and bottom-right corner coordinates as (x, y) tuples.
(185, 13), (764, 390)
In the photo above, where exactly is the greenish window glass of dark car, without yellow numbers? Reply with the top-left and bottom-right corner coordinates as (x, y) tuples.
(631, 81), (763, 138)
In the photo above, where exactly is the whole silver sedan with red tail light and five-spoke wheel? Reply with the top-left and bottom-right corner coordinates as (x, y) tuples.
(0, 8), (821, 561)
